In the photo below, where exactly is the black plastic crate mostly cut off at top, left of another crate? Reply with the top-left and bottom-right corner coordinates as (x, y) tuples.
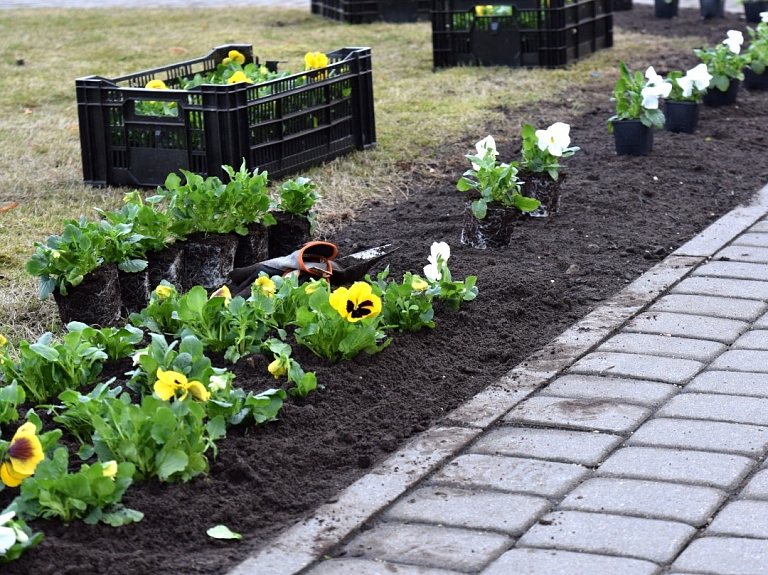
(311, 0), (431, 24)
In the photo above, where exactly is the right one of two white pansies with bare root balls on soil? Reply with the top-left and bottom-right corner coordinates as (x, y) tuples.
(518, 122), (579, 217)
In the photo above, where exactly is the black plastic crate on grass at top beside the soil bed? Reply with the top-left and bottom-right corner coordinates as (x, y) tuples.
(431, 0), (613, 68)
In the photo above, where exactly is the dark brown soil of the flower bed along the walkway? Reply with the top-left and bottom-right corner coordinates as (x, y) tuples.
(6, 5), (768, 575)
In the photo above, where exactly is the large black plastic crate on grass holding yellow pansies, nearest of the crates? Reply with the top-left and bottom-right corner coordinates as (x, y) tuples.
(76, 44), (376, 187)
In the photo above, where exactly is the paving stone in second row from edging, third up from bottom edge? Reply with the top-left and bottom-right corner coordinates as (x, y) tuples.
(558, 477), (727, 527)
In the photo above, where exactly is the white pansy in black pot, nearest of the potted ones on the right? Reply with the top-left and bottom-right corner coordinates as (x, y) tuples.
(608, 62), (671, 156)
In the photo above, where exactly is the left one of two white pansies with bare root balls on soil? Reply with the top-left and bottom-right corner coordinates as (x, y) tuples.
(456, 136), (540, 249)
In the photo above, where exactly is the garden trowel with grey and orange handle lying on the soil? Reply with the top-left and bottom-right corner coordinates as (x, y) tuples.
(229, 242), (399, 298)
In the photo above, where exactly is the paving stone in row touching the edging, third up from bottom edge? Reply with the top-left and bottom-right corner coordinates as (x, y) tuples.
(384, 485), (552, 535)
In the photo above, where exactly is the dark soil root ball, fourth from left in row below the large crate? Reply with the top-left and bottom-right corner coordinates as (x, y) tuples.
(182, 233), (237, 291)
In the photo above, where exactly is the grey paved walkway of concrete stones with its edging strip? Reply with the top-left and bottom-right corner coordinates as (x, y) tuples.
(230, 186), (768, 575)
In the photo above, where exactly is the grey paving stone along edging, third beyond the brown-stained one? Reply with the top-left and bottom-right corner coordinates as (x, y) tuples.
(596, 333), (728, 363)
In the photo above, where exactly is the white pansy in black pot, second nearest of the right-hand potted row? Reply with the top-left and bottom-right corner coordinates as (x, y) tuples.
(664, 63), (712, 134)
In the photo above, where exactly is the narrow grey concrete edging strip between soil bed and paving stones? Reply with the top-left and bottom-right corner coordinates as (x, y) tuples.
(229, 186), (768, 575)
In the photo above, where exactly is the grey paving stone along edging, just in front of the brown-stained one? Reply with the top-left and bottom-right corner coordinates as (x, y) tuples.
(469, 427), (623, 467)
